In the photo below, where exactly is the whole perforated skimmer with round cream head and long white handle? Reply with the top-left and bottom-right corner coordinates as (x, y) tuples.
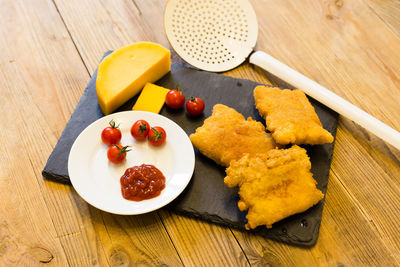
(164, 0), (400, 149)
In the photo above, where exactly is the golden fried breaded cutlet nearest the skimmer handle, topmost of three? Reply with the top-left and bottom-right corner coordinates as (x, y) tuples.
(254, 86), (333, 145)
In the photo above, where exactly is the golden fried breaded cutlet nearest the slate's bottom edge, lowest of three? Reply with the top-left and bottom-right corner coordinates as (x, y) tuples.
(224, 145), (324, 229)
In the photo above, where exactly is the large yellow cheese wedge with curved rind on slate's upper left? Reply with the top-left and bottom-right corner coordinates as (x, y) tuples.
(96, 42), (171, 115)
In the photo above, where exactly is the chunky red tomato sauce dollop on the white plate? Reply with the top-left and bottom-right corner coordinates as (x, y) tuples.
(120, 164), (165, 201)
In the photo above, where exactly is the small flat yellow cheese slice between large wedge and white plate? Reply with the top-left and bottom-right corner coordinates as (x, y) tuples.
(132, 83), (169, 113)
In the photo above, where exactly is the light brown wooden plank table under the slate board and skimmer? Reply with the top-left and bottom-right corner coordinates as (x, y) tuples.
(0, 0), (400, 266)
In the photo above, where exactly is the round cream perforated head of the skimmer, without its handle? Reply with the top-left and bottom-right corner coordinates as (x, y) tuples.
(164, 0), (258, 72)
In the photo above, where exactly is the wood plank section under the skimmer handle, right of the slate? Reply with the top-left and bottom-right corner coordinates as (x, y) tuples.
(332, 120), (400, 262)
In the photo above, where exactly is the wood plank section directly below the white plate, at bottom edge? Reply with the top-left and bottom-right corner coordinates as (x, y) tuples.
(90, 208), (182, 266)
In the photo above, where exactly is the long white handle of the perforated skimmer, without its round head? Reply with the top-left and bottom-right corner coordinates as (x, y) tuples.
(250, 51), (400, 150)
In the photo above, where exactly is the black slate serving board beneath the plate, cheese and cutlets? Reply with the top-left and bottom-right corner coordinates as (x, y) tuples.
(43, 51), (338, 246)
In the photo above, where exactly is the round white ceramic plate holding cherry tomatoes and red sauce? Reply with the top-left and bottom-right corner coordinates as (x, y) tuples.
(68, 111), (195, 215)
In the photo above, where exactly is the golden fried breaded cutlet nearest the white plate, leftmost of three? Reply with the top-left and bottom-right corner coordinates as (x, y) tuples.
(190, 104), (275, 167)
